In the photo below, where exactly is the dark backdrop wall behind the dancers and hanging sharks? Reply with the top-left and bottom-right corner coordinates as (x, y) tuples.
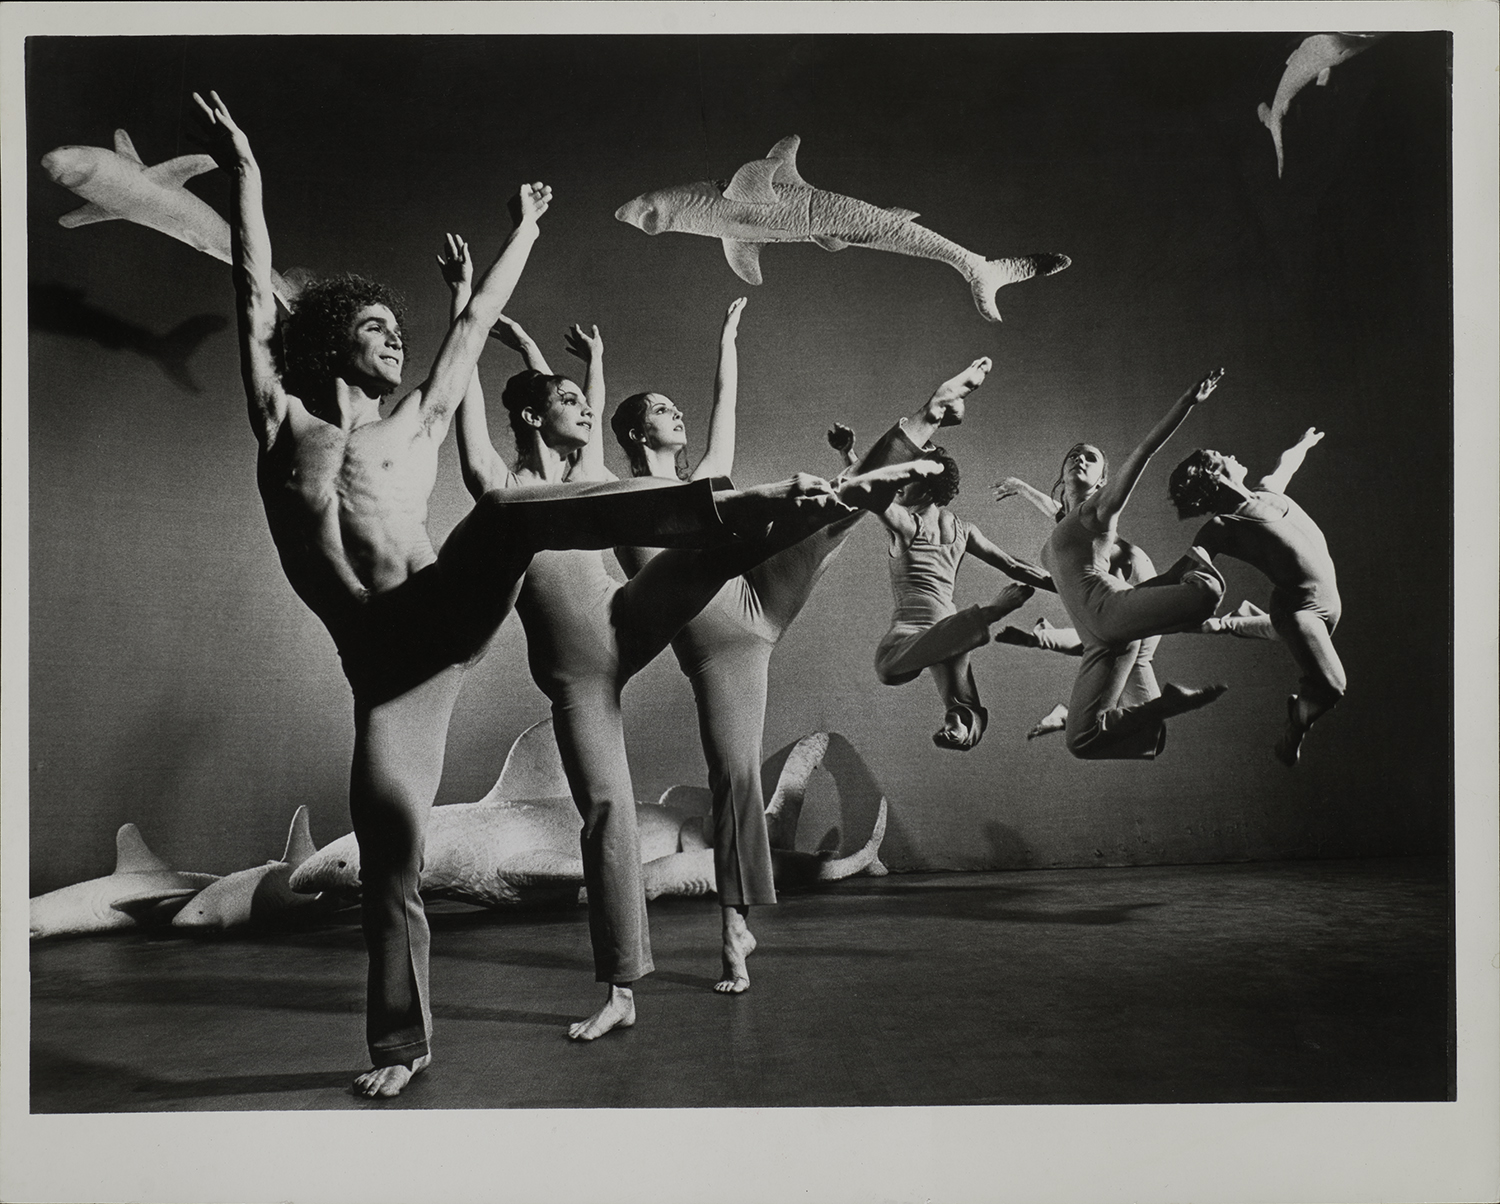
(27, 31), (1452, 894)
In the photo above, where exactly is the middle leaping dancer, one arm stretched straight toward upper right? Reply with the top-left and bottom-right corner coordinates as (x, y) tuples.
(1043, 372), (1226, 760)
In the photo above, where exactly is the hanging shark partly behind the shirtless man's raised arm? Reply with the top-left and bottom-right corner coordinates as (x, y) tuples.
(42, 129), (297, 306)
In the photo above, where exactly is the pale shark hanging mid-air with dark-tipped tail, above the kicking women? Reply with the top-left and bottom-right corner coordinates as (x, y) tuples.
(615, 133), (1073, 322)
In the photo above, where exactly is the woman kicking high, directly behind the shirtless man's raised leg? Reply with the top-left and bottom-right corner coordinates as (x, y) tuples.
(444, 240), (930, 1041)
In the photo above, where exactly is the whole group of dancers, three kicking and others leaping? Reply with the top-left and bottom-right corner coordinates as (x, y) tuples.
(195, 93), (1343, 1096)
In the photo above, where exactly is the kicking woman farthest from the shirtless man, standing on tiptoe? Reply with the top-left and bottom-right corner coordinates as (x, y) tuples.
(609, 297), (990, 994)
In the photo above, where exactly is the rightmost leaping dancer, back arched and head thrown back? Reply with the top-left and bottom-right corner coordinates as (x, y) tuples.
(1167, 427), (1347, 766)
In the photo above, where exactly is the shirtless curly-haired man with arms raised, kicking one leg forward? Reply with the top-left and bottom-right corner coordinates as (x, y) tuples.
(202, 93), (846, 1096)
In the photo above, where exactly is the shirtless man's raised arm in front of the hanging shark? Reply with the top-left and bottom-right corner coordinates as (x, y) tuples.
(192, 91), (288, 448)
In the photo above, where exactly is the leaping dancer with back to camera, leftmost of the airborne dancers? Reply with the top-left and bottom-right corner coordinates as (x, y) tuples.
(875, 447), (1053, 751)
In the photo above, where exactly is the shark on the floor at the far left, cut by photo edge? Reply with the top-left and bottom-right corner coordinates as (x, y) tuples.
(32, 823), (218, 940)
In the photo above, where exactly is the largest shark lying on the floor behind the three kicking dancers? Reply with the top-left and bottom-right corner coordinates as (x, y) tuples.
(290, 720), (887, 907)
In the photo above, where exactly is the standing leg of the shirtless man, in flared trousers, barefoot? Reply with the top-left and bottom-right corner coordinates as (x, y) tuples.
(350, 667), (464, 1096)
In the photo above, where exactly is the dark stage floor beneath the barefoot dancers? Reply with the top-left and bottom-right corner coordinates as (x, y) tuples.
(32, 858), (1452, 1113)
